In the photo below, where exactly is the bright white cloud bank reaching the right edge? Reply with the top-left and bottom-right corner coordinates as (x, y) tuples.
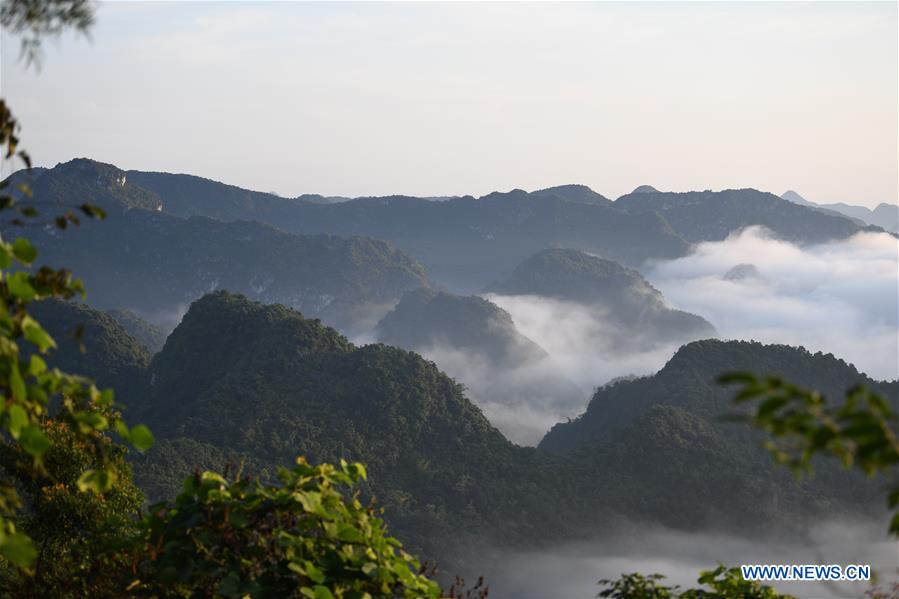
(645, 227), (899, 379)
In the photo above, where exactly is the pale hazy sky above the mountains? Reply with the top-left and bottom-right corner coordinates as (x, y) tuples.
(0, 2), (899, 205)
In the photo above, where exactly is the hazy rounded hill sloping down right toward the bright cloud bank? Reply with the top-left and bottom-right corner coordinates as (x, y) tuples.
(488, 248), (717, 346)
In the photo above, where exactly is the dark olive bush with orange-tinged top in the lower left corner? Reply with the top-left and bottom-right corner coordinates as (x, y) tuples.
(0, 420), (143, 597)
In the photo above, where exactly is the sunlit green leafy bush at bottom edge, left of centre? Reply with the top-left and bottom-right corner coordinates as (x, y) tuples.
(129, 458), (440, 599)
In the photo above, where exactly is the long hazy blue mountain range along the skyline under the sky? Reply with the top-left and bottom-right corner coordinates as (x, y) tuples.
(7, 159), (884, 298)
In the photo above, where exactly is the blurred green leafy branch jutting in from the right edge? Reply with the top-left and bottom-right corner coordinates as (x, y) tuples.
(721, 373), (899, 535)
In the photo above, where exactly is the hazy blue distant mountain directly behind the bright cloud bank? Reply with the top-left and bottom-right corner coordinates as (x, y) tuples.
(614, 189), (876, 243)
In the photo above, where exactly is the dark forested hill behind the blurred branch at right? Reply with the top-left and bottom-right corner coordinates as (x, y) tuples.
(539, 340), (899, 535)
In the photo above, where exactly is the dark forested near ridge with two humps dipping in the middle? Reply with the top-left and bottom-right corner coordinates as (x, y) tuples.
(35, 292), (897, 563)
